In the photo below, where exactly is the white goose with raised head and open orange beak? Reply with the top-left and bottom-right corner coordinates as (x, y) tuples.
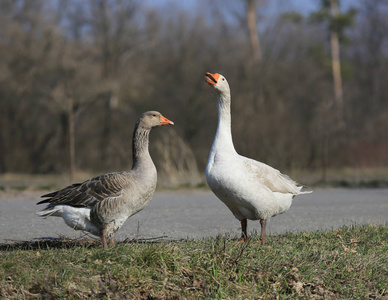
(205, 73), (310, 243)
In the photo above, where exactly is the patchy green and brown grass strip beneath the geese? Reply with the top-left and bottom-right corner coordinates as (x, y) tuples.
(0, 225), (388, 299)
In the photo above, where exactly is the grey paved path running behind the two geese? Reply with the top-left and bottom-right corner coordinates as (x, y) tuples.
(0, 189), (388, 243)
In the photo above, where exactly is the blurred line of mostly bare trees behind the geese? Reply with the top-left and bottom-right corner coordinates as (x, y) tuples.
(0, 0), (388, 184)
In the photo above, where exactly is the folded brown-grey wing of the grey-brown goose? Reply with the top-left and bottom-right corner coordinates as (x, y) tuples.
(37, 172), (129, 207)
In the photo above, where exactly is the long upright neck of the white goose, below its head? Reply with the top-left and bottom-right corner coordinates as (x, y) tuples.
(212, 93), (236, 153)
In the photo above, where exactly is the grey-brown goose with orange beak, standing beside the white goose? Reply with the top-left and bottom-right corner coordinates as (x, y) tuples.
(37, 111), (174, 248)
